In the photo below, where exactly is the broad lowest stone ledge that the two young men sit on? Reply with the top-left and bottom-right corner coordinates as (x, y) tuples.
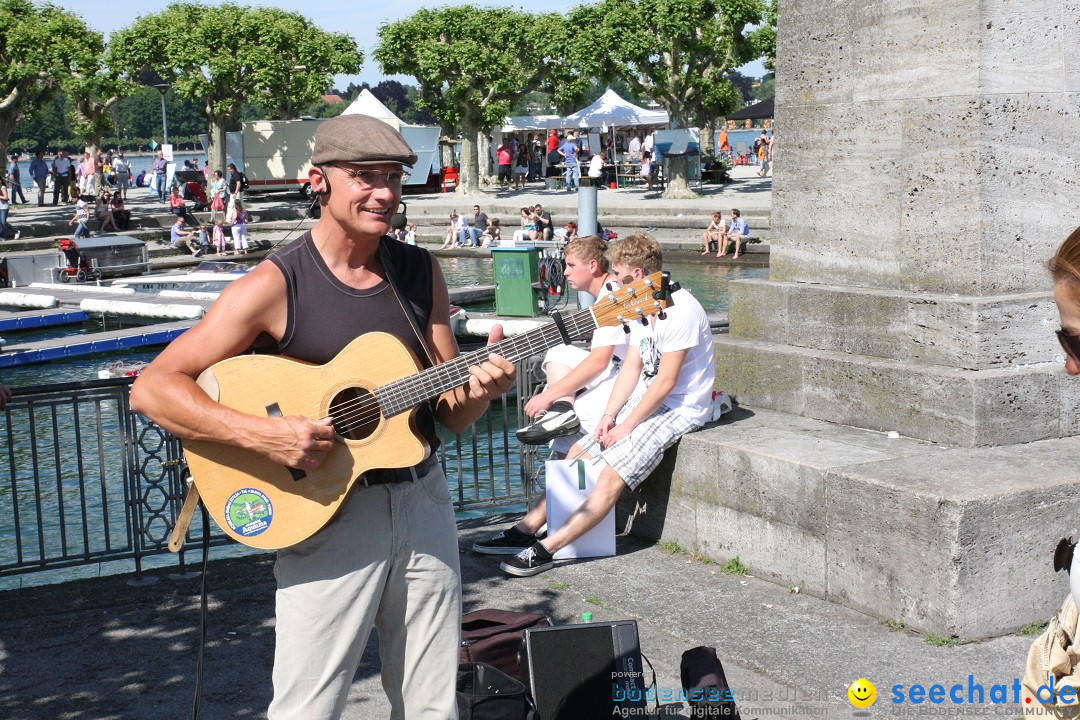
(619, 408), (1080, 640)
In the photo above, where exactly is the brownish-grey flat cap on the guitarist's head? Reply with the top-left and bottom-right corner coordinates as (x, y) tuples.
(311, 114), (417, 167)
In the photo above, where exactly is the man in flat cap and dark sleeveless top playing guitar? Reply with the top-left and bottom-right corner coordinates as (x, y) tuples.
(131, 114), (514, 720)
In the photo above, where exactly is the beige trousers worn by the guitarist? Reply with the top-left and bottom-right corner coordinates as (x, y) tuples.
(268, 461), (461, 720)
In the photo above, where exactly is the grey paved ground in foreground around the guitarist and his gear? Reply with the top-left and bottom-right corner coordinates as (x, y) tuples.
(0, 509), (1030, 720)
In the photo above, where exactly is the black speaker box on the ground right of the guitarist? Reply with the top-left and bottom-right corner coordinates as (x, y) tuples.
(525, 620), (646, 720)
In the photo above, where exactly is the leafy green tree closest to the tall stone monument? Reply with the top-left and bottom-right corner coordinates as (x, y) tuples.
(569, 0), (766, 198)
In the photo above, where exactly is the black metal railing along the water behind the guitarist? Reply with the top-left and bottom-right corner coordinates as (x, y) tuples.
(0, 358), (542, 580)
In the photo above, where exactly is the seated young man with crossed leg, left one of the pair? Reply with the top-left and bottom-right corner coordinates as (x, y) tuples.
(473, 235), (630, 555)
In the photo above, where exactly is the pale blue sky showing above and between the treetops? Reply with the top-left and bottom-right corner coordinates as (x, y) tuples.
(53, 0), (766, 90)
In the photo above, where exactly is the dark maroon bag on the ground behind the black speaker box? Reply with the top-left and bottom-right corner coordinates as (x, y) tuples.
(458, 608), (551, 680)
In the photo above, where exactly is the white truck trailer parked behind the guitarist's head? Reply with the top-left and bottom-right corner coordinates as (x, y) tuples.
(203, 118), (441, 200)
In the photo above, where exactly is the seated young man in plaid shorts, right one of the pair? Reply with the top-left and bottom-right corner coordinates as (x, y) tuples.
(479, 234), (715, 578)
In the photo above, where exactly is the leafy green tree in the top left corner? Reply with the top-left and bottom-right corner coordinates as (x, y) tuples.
(0, 0), (97, 166)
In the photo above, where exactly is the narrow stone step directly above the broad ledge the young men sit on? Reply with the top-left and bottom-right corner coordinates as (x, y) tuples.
(715, 334), (1080, 447)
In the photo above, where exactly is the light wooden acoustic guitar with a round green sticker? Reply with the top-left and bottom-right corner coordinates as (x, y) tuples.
(184, 272), (674, 549)
